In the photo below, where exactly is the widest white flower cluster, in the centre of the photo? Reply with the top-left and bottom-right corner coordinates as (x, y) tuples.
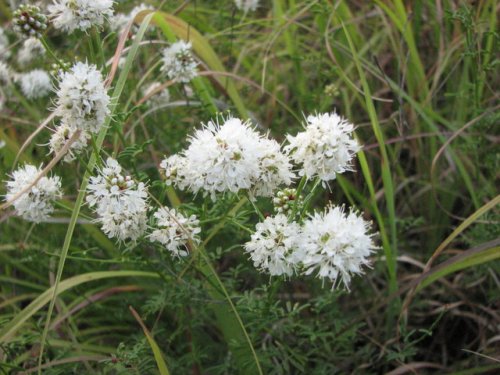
(160, 118), (295, 199)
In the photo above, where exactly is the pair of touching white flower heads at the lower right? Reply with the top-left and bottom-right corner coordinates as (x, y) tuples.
(245, 207), (376, 288)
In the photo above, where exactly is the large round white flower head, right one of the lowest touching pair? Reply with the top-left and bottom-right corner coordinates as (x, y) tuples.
(299, 207), (376, 288)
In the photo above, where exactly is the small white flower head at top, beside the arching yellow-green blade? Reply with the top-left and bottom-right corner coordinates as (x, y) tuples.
(161, 40), (198, 83)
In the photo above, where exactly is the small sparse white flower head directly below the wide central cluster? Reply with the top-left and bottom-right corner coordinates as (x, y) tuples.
(149, 208), (201, 257)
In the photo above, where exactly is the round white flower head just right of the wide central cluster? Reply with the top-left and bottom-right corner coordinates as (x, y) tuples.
(285, 113), (360, 182)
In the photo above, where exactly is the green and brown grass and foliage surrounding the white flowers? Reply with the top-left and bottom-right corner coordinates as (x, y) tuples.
(0, 0), (500, 374)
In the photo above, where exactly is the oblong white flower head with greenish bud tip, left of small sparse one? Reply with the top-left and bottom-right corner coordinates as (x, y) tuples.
(86, 158), (148, 241)
